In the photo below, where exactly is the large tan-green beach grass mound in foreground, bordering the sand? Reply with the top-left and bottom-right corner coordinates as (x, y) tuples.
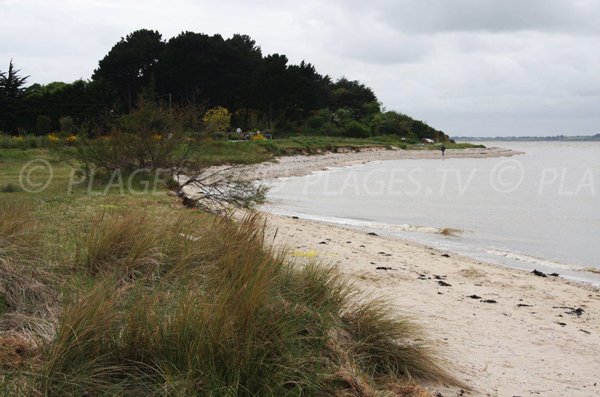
(35, 212), (455, 396)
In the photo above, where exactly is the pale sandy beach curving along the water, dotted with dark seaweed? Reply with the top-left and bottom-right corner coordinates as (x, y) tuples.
(184, 148), (600, 397)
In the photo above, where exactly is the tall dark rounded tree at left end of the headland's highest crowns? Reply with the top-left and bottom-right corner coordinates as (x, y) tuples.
(92, 29), (164, 112)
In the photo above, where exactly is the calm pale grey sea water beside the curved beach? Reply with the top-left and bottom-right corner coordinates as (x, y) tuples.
(267, 142), (600, 285)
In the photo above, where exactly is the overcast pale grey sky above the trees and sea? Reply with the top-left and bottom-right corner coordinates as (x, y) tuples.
(0, 0), (600, 136)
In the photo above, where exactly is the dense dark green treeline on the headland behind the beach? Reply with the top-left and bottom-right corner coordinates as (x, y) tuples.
(0, 30), (447, 141)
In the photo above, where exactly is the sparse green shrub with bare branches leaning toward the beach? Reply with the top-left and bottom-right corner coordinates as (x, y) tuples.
(64, 97), (266, 213)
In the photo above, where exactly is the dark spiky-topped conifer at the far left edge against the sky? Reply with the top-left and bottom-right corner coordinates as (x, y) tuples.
(0, 60), (29, 133)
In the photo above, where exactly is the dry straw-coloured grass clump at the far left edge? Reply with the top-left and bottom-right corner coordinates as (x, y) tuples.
(0, 201), (58, 382)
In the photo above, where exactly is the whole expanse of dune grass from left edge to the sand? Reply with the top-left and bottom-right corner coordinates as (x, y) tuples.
(0, 148), (458, 396)
